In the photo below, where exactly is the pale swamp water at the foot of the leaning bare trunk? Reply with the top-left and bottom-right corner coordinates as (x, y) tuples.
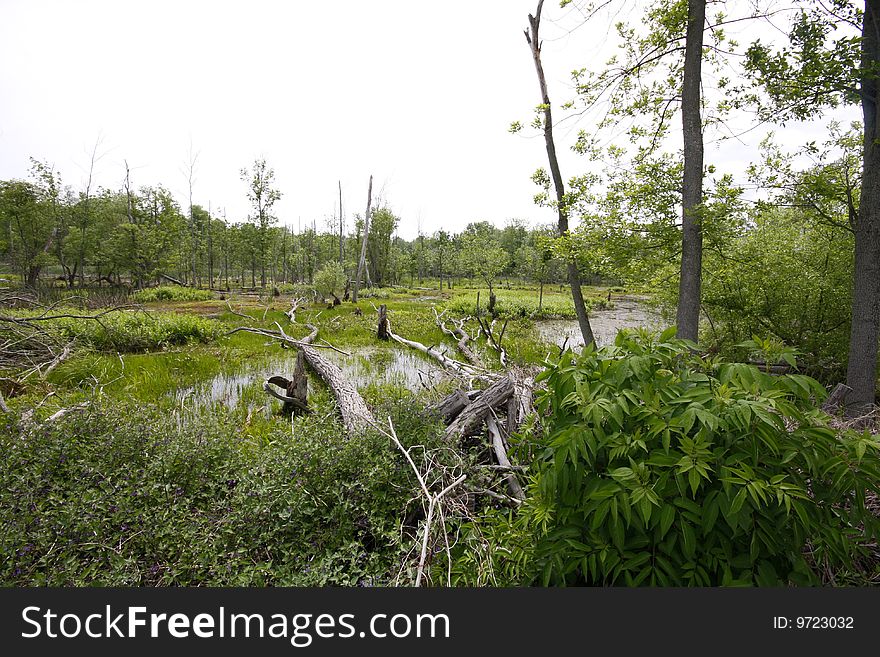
(535, 298), (666, 348)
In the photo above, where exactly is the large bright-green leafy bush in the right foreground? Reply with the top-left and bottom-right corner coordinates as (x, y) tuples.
(456, 331), (880, 586)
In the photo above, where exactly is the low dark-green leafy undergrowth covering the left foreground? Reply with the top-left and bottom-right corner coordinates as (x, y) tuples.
(0, 399), (437, 586)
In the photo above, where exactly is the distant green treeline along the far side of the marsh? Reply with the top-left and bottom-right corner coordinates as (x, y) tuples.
(0, 160), (576, 289)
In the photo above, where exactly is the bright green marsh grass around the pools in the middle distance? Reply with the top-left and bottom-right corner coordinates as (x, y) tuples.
(13, 288), (628, 405)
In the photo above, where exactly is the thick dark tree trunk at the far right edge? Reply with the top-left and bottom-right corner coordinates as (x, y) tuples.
(846, 0), (880, 416)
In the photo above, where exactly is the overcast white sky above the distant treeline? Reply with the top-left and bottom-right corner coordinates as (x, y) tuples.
(0, 0), (860, 238)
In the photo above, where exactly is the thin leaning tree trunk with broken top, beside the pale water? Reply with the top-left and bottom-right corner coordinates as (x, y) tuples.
(525, 0), (595, 344)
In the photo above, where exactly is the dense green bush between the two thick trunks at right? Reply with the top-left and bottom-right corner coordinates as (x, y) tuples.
(703, 211), (853, 383)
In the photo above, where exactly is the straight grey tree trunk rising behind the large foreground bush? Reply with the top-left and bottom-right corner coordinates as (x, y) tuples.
(676, 0), (706, 342)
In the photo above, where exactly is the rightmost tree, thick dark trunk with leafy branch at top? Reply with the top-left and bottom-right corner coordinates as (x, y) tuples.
(746, 0), (880, 416)
